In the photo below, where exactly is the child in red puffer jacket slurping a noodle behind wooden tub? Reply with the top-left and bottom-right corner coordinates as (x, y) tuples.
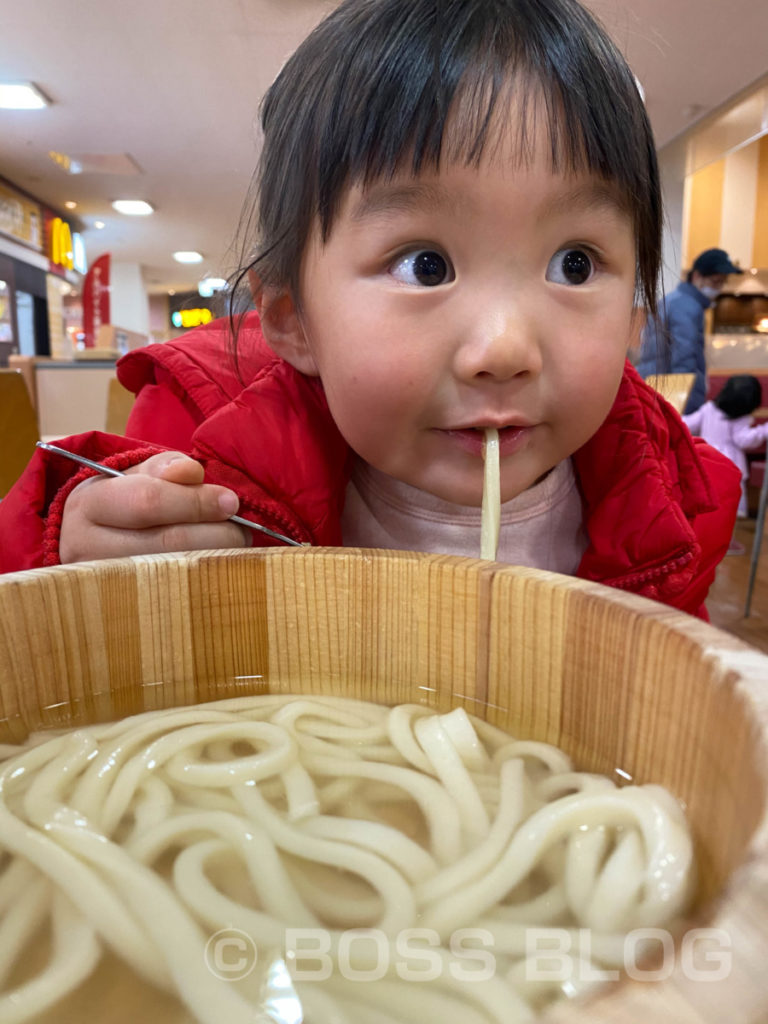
(0, 0), (738, 614)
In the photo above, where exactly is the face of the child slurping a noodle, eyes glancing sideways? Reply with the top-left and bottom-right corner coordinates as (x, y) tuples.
(288, 132), (635, 505)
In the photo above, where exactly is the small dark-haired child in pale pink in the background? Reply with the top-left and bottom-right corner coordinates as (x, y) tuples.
(683, 374), (768, 555)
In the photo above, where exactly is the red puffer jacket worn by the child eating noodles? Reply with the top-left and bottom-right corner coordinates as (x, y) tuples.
(0, 313), (740, 616)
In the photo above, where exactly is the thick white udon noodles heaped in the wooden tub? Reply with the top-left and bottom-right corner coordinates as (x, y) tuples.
(0, 695), (693, 1024)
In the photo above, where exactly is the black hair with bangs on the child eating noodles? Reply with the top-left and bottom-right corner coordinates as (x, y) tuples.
(232, 0), (662, 313)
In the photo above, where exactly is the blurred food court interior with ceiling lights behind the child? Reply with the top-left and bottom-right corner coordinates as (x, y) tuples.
(0, 0), (768, 649)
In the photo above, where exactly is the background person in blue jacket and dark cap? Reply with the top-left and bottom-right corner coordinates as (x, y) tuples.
(637, 249), (743, 416)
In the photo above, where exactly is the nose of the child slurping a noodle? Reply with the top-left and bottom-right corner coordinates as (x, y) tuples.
(457, 308), (542, 381)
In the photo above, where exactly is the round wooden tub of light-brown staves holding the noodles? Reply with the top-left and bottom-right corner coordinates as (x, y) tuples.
(0, 549), (768, 1024)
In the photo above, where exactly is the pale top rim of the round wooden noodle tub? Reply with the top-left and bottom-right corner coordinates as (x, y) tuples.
(0, 547), (768, 1024)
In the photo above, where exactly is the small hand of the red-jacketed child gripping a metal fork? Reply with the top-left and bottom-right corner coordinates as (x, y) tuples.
(58, 452), (250, 563)
